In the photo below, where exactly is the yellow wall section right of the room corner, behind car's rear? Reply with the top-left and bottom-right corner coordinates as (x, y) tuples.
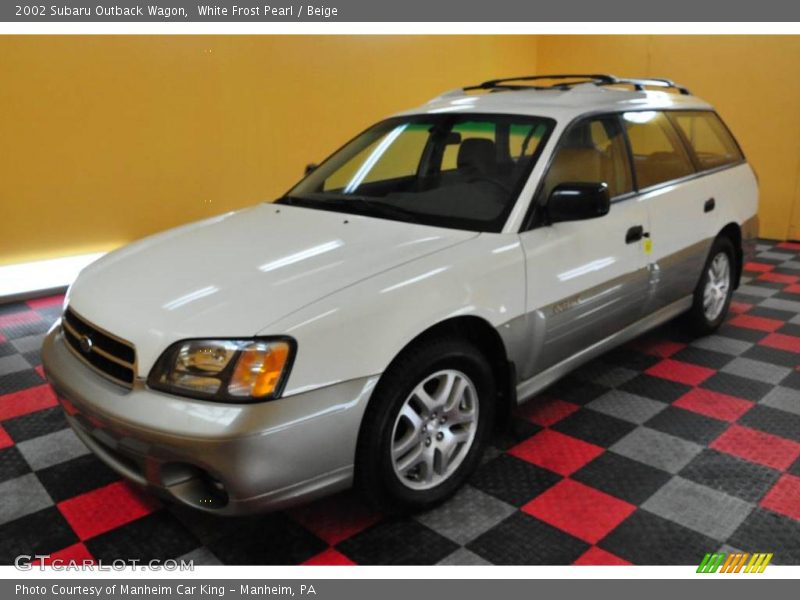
(537, 36), (800, 239)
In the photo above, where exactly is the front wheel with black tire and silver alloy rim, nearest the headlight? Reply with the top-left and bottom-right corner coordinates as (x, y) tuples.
(355, 337), (496, 513)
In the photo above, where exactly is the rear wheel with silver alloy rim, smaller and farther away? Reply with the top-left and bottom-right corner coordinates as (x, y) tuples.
(686, 237), (738, 336)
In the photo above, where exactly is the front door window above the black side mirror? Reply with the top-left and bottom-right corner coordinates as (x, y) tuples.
(541, 115), (633, 201)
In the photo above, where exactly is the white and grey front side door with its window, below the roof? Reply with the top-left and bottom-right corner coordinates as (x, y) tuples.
(518, 115), (648, 379)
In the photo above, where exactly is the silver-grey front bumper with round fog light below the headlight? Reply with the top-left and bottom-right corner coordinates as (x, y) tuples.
(42, 325), (377, 515)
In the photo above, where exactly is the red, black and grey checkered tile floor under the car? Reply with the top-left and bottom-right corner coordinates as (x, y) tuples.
(0, 242), (800, 565)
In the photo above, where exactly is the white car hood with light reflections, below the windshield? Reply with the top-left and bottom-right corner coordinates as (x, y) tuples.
(67, 204), (477, 374)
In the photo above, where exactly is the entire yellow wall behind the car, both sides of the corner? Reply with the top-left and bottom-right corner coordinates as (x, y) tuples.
(0, 36), (800, 264)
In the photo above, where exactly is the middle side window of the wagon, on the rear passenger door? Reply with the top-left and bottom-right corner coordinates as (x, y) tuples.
(622, 111), (694, 189)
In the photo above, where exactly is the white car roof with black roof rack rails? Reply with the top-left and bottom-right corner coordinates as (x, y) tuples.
(398, 76), (712, 121)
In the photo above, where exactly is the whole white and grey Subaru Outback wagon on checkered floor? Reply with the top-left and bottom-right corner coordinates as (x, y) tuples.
(43, 75), (758, 514)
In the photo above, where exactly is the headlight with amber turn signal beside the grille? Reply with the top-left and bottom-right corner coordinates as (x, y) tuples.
(147, 338), (295, 402)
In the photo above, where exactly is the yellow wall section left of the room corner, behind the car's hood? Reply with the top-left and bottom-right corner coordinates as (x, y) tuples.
(0, 36), (536, 264)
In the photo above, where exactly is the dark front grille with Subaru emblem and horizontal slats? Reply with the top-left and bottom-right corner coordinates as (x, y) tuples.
(61, 308), (136, 388)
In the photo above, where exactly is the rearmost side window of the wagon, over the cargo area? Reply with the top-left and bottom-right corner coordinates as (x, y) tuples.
(670, 111), (744, 171)
